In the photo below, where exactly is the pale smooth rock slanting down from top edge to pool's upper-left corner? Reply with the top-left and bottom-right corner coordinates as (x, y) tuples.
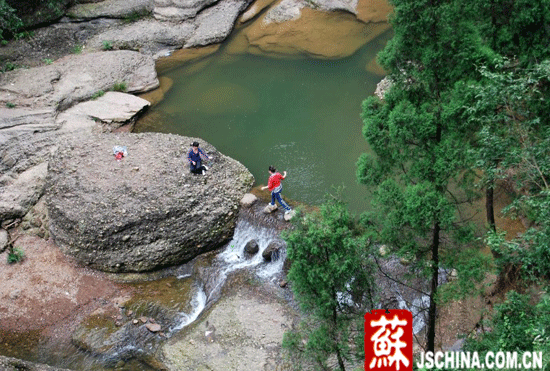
(184, 0), (254, 48)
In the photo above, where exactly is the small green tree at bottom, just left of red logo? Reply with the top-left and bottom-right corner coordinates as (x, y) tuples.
(283, 198), (374, 370)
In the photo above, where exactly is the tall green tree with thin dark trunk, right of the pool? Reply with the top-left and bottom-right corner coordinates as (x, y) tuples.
(358, 0), (492, 351)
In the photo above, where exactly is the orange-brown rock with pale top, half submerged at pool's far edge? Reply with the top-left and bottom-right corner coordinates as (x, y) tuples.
(241, 0), (391, 59)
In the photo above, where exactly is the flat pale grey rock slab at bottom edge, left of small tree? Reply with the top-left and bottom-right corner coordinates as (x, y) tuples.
(159, 285), (293, 371)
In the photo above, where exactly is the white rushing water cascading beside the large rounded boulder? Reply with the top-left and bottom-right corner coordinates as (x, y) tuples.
(171, 220), (286, 332)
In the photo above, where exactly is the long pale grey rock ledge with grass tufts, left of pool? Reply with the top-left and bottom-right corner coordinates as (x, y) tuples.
(0, 50), (159, 110)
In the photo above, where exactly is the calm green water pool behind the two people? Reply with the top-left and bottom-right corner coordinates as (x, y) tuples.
(136, 31), (391, 213)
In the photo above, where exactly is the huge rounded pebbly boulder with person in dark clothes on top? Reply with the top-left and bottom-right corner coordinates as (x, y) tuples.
(46, 133), (254, 272)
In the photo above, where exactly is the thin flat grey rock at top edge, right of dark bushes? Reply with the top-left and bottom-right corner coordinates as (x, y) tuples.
(68, 0), (154, 19)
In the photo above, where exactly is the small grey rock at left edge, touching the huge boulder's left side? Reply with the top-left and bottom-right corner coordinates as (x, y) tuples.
(0, 162), (48, 220)
